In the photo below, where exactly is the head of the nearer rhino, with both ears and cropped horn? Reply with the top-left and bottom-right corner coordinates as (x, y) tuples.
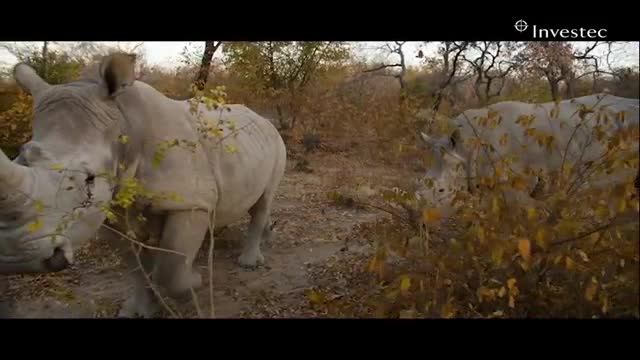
(0, 55), (135, 274)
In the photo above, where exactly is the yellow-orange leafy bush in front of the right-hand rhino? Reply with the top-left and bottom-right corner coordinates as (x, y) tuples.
(356, 102), (640, 318)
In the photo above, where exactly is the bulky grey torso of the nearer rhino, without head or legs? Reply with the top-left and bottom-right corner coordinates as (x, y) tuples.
(119, 83), (286, 225)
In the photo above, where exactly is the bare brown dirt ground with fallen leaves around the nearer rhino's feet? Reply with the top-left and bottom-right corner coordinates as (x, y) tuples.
(0, 146), (416, 318)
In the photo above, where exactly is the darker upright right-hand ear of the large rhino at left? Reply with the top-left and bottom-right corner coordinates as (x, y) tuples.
(100, 53), (136, 96)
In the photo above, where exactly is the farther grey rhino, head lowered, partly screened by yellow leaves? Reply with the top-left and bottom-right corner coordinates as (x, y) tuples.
(417, 94), (639, 210)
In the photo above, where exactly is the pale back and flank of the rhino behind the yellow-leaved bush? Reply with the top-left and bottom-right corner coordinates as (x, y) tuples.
(455, 95), (638, 179)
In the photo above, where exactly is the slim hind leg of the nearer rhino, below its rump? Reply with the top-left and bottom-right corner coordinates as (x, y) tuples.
(238, 192), (274, 268)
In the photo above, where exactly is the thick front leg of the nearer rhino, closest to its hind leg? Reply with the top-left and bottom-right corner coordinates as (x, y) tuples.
(153, 211), (209, 297)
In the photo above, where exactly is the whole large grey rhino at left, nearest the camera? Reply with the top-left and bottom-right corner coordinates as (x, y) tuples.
(0, 53), (287, 316)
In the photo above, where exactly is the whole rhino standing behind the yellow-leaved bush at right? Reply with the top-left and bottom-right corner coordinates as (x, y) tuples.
(418, 94), (639, 211)
